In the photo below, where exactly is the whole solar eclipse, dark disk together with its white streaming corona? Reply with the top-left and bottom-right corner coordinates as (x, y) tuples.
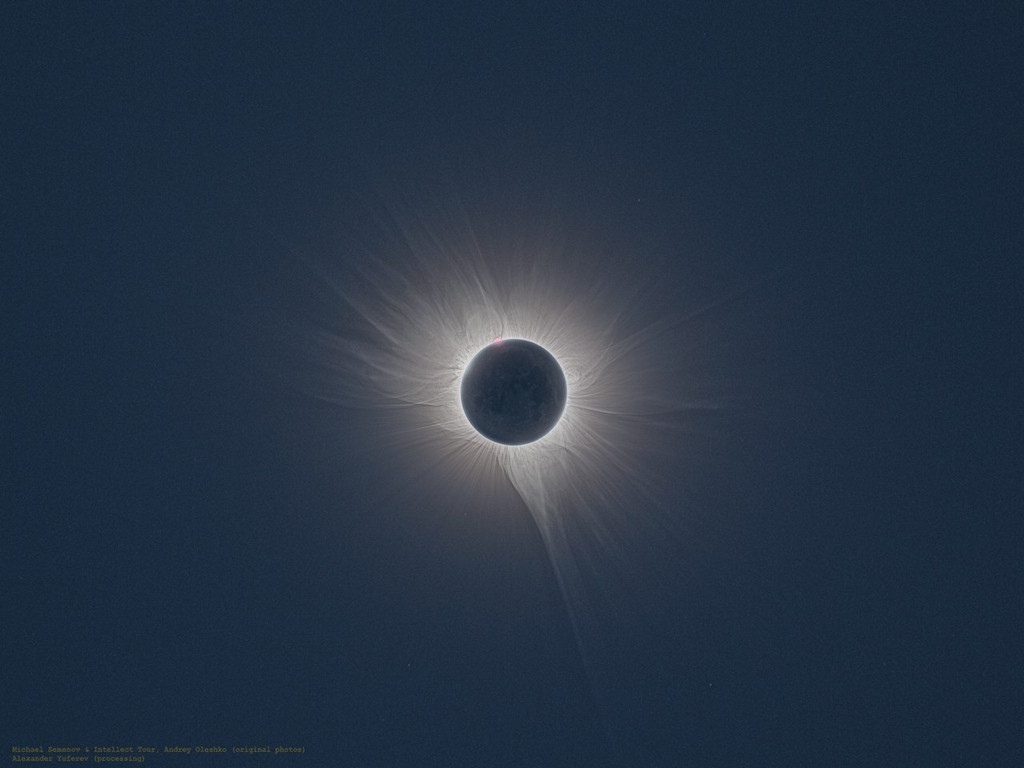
(286, 179), (754, 765)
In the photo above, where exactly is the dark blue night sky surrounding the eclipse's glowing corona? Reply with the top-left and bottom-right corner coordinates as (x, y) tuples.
(0, 2), (1024, 766)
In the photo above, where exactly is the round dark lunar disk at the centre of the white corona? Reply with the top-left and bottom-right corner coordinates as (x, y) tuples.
(462, 339), (566, 445)
